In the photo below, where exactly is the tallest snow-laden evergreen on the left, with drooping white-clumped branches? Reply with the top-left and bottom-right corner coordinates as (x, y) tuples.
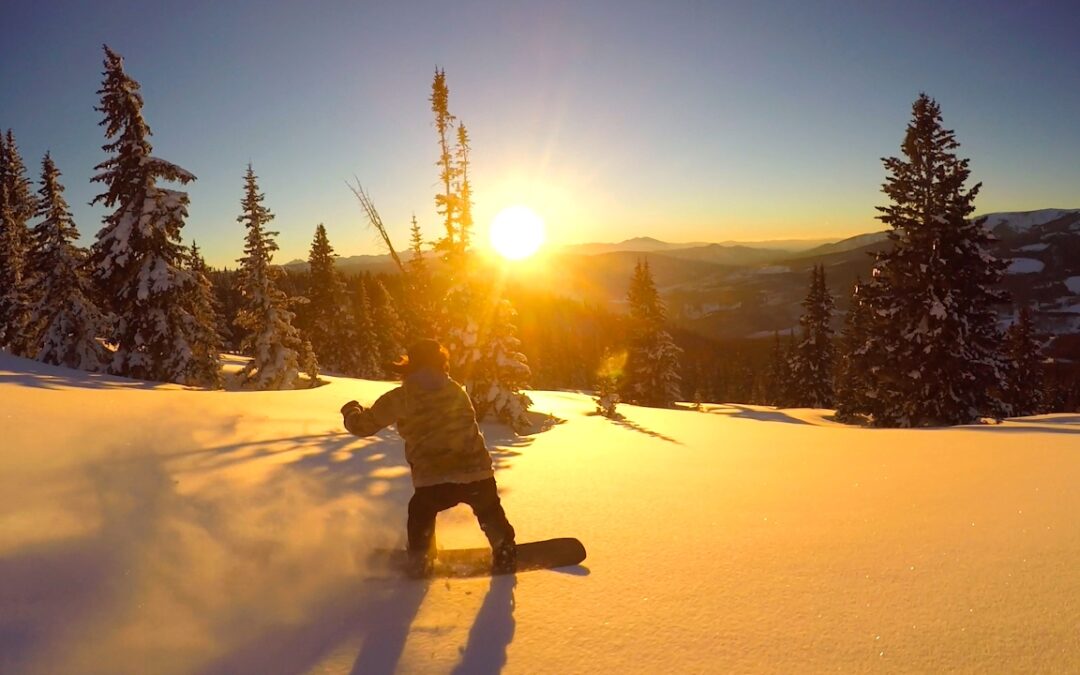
(91, 46), (210, 383)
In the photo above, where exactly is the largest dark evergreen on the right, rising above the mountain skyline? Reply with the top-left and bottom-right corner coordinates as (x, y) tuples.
(864, 94), (1004, 427)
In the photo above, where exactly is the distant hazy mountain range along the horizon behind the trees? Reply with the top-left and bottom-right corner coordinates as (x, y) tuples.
(285, 208), (1080, 347)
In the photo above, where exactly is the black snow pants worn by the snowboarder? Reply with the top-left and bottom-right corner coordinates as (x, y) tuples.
(407, 478), (514, 554)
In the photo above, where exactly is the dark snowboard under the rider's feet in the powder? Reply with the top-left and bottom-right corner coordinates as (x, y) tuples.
(372, 537), (585, 578)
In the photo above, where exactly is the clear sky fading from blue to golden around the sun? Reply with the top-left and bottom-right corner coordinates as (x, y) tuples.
(0, 0), (1080, 267)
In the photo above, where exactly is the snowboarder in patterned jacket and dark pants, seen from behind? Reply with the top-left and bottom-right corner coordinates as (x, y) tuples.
(341, 339), (517, 577)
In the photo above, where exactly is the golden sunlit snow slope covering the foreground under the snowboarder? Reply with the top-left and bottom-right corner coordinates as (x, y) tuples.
(0, 354), (1080, 675)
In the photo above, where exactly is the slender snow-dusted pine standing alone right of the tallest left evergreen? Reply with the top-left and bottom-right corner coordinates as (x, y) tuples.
(237, 164), (318, 389)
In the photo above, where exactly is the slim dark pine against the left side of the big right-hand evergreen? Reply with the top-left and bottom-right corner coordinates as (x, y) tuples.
(835, 279), (873, 422)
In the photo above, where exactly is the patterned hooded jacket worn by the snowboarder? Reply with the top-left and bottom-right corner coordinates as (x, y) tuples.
(345, 369), (495, 487)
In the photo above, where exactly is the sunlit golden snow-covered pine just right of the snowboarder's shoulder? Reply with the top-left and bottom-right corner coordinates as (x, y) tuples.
(464, 299), (532, 432)
